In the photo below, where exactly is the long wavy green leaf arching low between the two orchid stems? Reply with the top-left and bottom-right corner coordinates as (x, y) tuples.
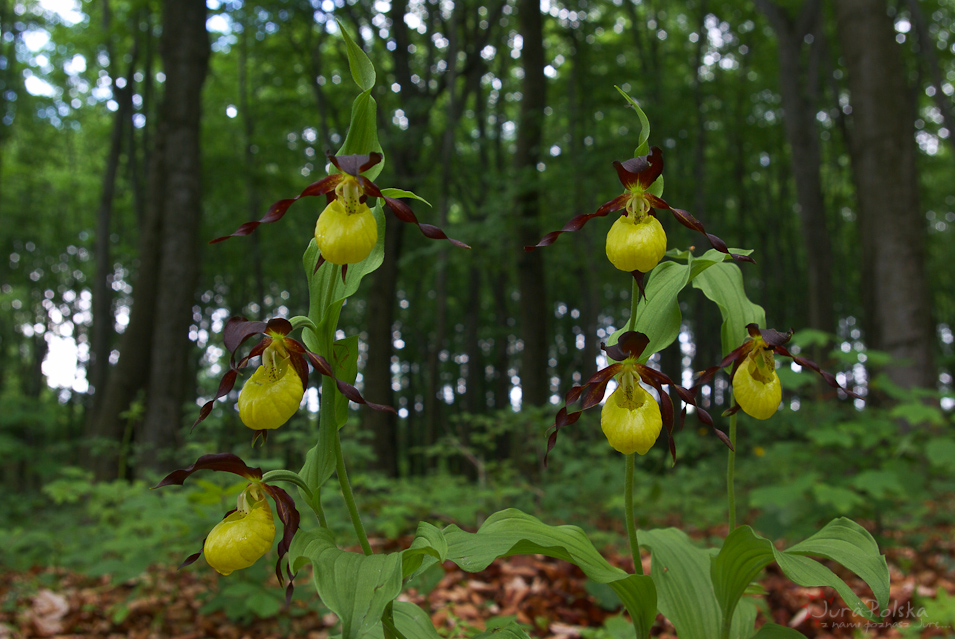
(444, 508), (657, 637)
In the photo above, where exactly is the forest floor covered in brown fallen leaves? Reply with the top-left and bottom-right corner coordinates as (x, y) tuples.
(0, 530), (955, 639)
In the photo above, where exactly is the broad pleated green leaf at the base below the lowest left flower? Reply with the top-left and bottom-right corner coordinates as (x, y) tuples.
(289, 528), (401, 639)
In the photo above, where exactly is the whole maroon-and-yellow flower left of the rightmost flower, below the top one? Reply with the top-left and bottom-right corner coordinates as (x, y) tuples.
(545, 331), (713, 462)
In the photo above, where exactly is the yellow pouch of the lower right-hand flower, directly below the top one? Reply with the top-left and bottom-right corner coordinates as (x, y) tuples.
(600, 373), (663, 455)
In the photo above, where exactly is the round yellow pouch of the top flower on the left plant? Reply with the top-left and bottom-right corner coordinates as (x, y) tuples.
(315, 199), (378, 264)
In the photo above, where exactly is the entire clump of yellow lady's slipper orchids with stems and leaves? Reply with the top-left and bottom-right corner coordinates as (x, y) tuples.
(158, 25), (889, 639)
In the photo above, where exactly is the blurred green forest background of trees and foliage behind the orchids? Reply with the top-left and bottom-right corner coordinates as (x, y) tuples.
(0, 0), (955, 636)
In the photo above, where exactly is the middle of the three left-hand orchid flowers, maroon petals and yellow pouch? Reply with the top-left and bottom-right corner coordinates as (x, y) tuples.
(193, 317), (394, 437)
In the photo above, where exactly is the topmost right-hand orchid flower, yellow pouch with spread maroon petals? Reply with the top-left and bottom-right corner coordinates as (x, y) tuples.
(524, 146), (753, 273)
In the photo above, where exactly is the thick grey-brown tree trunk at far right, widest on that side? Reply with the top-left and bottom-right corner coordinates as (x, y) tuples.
(835, 0), (936, 388)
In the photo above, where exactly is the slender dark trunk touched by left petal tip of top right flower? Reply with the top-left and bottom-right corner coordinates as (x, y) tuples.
(514, 0), (550, 406)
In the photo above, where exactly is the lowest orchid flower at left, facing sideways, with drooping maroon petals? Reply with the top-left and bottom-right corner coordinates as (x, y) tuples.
(155, 453), (300, 599)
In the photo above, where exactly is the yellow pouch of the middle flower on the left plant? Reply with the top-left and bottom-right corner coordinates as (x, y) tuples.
(239, 356), (305, 430)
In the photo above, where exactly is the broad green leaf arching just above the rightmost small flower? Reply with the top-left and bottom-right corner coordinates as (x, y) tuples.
(693, 262), (766, 355)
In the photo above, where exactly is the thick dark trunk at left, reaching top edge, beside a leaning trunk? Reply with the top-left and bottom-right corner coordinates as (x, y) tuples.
(137, 0), (209, 470)
